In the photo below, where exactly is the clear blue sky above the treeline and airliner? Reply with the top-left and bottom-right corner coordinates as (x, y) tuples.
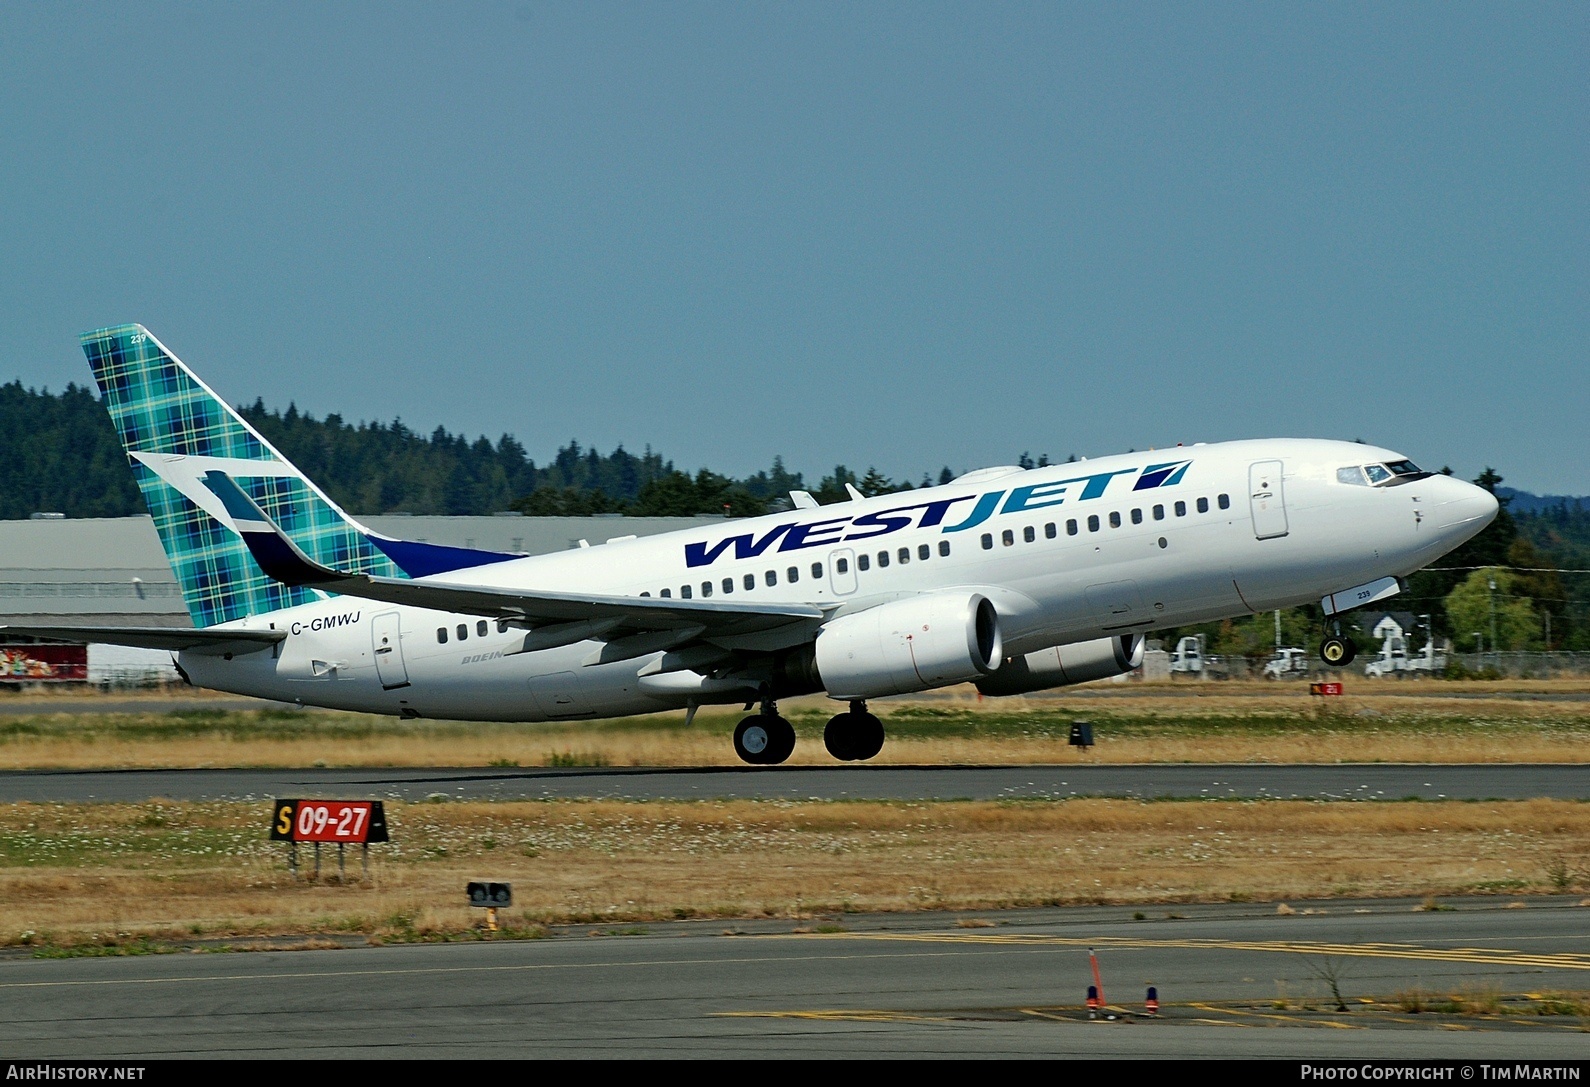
(0, 0), (1590, 494)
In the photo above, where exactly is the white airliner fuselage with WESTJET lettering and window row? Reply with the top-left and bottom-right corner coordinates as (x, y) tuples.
(180, 439), (1496, 721)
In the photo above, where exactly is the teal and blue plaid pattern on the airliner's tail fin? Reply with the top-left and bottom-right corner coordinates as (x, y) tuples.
(83, 324), (404, 626)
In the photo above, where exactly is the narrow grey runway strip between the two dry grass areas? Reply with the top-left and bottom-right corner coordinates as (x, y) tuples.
(0, 763), (1590, 803)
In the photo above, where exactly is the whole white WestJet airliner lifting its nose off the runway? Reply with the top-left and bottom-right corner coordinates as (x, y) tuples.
(10, 324), (1498, 764)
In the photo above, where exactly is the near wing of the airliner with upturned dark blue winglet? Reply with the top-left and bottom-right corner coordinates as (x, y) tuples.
(205, 472), (824, 639)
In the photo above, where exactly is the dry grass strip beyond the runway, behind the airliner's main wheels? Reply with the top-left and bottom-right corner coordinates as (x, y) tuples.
(0, 679), (1590, 769)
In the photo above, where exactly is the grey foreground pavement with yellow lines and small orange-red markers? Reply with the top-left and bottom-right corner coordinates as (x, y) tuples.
(0, 899), (1590, 1062)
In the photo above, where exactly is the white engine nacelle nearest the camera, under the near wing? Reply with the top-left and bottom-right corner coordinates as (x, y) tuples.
(816, 591), (1003, 699)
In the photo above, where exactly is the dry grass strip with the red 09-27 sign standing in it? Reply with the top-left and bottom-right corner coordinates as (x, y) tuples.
(0, 799), (1590, 949)
